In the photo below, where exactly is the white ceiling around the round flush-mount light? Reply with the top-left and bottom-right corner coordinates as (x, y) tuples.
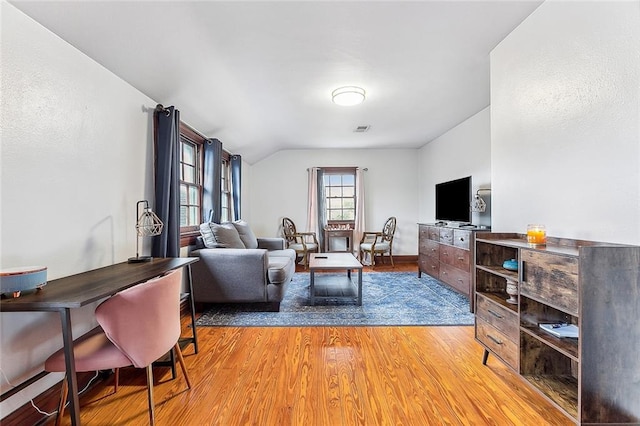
(11, 0), (542, 163)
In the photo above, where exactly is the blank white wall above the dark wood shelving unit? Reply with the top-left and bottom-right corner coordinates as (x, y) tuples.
(491, 1), (640, 244)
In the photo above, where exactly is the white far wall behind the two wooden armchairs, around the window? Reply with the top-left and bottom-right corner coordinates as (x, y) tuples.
(245, 149), (418, 255)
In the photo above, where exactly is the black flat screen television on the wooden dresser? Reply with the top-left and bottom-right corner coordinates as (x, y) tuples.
(436, 176), (471, 223)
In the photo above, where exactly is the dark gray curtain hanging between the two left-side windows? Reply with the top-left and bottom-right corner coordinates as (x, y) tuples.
(202, 139), (222, 223)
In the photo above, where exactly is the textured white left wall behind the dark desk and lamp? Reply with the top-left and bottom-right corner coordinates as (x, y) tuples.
(0, 1), (156, 418)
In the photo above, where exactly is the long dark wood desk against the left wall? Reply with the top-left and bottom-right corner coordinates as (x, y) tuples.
(0, 257), (198, 425)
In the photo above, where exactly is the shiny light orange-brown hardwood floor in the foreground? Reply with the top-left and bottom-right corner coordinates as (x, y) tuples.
(48, 268), (573, 426)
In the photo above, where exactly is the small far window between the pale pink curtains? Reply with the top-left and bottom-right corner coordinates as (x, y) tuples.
(323, 168), (356, 225)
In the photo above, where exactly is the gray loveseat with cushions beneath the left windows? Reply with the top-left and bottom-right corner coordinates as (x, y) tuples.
(189, 221), (296, 310)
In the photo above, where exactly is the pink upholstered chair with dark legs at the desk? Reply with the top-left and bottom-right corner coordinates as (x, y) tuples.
(45, 270), (191, 425)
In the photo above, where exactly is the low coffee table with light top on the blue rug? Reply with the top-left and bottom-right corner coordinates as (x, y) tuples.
(309, 253), (362, 305)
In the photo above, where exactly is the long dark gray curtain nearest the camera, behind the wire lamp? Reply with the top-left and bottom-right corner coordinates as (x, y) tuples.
(151, 105), (180, 257)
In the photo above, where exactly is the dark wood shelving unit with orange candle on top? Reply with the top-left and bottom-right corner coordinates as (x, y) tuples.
(474, 233), (640, 424)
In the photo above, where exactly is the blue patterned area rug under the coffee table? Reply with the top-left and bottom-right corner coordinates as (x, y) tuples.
(196, 272), (473, 327)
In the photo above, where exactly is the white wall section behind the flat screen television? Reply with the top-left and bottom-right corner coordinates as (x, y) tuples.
(418, 107), (491, 225)
